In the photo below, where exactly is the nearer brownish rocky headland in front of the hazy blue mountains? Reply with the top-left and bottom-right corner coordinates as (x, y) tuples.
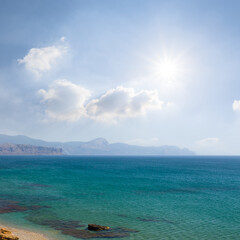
(0, 143), (63, 155)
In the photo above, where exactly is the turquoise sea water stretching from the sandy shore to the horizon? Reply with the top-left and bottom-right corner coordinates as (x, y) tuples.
(0, 156), (240, 240)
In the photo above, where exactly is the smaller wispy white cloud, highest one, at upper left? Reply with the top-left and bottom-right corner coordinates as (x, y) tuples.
(18, 46), (67, 77)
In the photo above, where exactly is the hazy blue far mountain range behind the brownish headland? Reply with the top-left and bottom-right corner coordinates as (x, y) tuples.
(0, 134), (194, 156)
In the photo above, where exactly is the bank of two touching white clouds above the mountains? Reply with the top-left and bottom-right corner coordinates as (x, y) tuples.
(39, 80), (163, 122)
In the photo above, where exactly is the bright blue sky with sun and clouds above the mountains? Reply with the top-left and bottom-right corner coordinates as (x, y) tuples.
(0, 0), (240, 155)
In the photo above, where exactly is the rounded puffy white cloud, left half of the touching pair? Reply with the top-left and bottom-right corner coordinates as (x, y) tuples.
(39, 80), (90, 121)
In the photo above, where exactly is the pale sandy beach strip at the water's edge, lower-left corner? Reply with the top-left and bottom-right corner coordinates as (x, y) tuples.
(0, 223), (50, 240)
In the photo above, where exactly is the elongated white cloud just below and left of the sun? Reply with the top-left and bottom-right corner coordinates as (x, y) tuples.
(86, 86), (163, 121)
